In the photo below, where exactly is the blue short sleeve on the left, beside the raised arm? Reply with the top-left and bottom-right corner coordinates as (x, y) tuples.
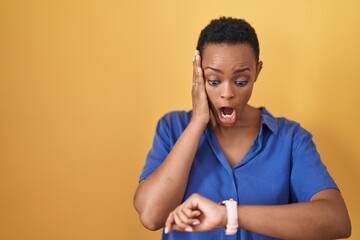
(139, 117), (171, 181)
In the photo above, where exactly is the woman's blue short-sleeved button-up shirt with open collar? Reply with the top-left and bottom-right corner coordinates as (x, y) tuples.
(140, 108), (337, 240)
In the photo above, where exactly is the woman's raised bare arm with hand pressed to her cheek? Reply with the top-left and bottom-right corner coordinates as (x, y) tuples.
(134, 52), (210, 230)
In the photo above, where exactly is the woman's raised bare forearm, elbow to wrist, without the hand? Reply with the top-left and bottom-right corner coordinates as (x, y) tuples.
(134, 122), (205, 230)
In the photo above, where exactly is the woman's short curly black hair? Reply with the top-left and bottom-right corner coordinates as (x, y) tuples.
(196, 17), (260, 62)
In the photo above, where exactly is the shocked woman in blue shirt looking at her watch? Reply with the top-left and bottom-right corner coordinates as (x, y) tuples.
(134, 17), (351, 240)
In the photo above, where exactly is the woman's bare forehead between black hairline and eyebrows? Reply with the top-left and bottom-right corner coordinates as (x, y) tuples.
(202, 44), (256, 68)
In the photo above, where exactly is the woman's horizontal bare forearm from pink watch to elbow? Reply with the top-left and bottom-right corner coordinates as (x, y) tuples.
(238, 190), (351, 239)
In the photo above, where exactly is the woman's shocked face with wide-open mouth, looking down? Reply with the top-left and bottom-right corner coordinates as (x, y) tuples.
(202, 44), (262, 127)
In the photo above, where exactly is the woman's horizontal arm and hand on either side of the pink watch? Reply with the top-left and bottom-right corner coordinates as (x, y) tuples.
(165, 189), (351, 239)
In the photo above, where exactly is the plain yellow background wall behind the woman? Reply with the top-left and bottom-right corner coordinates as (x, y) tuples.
(0, 0), (360, 240)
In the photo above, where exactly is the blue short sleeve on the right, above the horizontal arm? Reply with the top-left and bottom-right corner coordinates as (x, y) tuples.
(290, 126), (338, 202)
